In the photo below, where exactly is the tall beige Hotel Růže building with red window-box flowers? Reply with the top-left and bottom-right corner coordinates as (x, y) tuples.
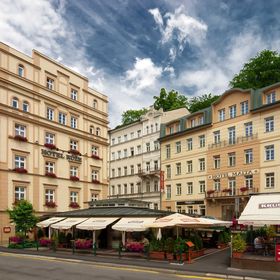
(0, 43), (108, 242)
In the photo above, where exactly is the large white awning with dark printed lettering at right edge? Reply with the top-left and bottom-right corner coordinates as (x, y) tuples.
(238, 194), (280, 226)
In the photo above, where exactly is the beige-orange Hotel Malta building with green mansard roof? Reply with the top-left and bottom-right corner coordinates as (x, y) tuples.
(160, 83), (280, 220)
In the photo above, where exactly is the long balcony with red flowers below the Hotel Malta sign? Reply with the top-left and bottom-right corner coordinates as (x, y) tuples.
(205, 187), (259, 199)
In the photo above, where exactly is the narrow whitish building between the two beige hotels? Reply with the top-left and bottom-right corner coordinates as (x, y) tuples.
(109, 107), (188, 209)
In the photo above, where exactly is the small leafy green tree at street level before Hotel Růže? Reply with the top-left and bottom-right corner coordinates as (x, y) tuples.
(7, 200), (38, 237)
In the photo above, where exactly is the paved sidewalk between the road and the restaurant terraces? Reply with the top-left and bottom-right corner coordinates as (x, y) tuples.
(0, 247), (280, 280)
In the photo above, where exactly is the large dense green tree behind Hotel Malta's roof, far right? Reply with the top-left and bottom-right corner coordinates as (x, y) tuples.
(229, 50), (280, 89)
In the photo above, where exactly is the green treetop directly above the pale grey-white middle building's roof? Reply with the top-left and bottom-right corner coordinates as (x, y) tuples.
(154, 88), (188, 111)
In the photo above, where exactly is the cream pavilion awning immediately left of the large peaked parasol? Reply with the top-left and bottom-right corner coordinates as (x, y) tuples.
(112, 218), (156, 232)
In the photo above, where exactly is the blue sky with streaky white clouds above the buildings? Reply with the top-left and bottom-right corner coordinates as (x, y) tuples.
(0, 0), (280, 127)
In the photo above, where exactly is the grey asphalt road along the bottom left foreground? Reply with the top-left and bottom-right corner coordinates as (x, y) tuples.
(0, 253), (224, 280)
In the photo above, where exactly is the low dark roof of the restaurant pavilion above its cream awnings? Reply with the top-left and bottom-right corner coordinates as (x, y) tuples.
(54, 207), (170, 218)
